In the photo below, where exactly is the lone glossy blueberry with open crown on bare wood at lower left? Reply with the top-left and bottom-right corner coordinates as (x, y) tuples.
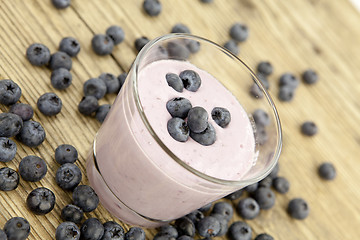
(26, 187), (55, 215)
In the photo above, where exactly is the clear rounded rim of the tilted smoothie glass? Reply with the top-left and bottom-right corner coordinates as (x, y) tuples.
(132, 33), (282, 186)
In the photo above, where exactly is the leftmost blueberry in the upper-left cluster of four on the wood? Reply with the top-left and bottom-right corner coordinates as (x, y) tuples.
(26, 43), (50, 66)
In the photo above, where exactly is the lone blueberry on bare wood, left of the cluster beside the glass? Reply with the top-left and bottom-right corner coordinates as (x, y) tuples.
(36, 92), (62, 116)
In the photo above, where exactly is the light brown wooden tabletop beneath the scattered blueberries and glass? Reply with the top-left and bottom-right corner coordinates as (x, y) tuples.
(0, 0), (360, 239)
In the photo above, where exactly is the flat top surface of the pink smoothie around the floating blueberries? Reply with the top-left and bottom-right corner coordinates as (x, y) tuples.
(138, 60), (256, 180)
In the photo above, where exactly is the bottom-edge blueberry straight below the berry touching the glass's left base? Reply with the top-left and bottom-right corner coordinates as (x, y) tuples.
(80, 218), (104, 240)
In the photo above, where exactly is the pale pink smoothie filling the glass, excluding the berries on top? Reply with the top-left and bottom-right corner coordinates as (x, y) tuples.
(87, 60), (256, 227)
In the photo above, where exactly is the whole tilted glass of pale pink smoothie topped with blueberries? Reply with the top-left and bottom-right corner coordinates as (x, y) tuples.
(87, 34), (281, 227)
